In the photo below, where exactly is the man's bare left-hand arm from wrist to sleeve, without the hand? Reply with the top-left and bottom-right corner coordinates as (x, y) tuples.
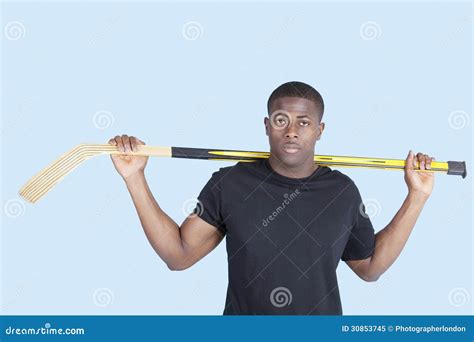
(125, 172), (224, 270)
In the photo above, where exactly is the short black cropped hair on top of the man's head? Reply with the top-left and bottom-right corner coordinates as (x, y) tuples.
(267, 81), (324, 122)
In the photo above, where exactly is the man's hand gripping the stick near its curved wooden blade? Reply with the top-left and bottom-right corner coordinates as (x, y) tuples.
(109, 134), (148, 181)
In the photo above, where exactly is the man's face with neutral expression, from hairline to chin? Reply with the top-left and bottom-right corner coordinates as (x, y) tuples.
(264, 97), (324, 167)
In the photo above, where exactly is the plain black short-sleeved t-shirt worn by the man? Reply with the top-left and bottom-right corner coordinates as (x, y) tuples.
(196, 159), (375, 315)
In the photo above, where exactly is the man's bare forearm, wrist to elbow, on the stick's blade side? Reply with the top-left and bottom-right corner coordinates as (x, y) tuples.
(125, 173), (183, 267)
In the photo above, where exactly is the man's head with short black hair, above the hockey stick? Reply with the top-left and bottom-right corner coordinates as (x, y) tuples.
(264, 81), (324, 167)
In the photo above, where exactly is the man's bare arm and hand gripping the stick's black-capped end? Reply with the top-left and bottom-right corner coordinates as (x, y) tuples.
(346, 151), (435, 281)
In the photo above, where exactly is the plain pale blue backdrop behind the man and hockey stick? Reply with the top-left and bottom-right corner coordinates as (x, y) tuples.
(1, 2), (473, 315)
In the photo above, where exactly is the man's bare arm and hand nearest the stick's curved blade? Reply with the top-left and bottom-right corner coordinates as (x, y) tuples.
(109, 134), (224, 270)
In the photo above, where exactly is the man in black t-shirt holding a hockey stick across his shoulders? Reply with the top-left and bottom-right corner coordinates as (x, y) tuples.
(109, 82), (434, 315)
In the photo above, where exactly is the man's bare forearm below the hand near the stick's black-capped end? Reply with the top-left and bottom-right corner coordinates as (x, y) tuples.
(368, 192), (428, 279)
